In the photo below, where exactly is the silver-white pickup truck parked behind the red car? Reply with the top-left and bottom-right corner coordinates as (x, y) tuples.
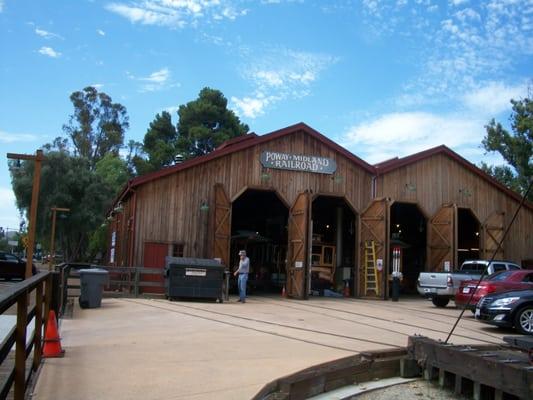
(416, 260), (520, 307)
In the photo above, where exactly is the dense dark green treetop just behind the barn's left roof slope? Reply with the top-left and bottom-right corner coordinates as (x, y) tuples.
(177, 87), (249, 159)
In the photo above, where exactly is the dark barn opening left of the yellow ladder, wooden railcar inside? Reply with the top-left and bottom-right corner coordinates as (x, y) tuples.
(311, 196), (356, 294)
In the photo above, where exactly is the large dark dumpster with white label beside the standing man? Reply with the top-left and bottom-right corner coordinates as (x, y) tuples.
(165, 257), (225, 303)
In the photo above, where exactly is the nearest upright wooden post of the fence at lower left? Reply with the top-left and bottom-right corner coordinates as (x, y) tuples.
(14, 291), (28, 400)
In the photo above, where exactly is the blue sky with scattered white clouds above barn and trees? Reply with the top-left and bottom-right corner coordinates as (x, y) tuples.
(0, 0), (533, 231)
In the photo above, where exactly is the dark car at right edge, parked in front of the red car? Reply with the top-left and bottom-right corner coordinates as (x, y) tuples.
(475, 290), (533, 335)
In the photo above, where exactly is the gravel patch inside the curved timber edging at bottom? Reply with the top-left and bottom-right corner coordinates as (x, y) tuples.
(352, 379), (468, 400)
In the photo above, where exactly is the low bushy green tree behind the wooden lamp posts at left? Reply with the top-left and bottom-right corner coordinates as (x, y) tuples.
(10, 150), (116, 260)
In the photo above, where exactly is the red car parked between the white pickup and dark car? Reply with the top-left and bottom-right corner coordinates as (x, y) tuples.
(455, 269), (533, 311)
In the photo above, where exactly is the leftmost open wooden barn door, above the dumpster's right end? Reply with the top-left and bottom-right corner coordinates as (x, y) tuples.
(213, 183), (231, 269)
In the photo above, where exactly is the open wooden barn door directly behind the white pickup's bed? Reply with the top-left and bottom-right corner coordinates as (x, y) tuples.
(428, 204), (457, 271)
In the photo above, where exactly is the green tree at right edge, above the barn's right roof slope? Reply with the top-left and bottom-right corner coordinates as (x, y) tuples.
(482, 98), (533, 200)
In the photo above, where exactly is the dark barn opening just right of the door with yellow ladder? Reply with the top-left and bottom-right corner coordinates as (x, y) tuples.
(389, 203), (427, 294)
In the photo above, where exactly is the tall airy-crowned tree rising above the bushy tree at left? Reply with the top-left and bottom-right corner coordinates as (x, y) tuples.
(63, 86), (129, 169)
